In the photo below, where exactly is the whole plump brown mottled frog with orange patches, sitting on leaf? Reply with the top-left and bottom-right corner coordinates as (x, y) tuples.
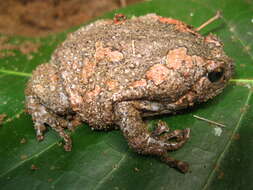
(26, 14), (233, 172)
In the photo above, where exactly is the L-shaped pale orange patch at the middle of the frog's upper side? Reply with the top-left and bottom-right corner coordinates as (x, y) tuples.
(94, 42), (124, 62)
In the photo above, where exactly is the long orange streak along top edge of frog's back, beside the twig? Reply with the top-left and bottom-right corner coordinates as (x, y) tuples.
(158, 17), (199, 35)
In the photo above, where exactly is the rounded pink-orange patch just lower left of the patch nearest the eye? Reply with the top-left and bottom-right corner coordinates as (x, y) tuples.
(146, 64), (170, 85)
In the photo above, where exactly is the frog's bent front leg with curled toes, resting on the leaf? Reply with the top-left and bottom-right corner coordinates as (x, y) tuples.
(115, 101), (190, 173)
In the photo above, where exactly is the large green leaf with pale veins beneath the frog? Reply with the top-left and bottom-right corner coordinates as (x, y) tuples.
(0, 0), (253, 190)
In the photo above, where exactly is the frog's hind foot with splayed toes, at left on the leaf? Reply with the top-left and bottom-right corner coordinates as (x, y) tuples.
(27, 96), (73, 151)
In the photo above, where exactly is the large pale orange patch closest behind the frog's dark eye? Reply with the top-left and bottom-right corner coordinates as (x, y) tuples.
(167, 47), (204, 70)
